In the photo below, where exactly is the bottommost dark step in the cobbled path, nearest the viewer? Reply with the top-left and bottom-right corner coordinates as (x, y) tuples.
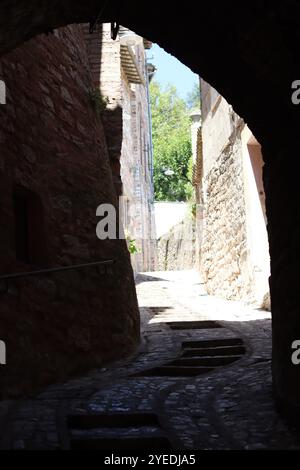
(70, 436), (172, 451)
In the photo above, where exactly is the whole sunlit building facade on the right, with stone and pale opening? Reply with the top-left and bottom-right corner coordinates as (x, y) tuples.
(194, 80), (270, 308)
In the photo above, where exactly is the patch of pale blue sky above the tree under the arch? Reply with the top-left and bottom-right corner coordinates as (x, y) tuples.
(147, 44), (199, 99)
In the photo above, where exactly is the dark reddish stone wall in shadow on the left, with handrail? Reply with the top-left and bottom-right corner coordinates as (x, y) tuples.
(0, 22), (139, 396)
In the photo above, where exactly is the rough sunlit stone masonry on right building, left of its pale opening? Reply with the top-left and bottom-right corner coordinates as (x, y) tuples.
(201, 132), (253, 300)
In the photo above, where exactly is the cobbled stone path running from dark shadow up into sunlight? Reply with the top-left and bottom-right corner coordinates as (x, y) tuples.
(0, 271), (300, 450)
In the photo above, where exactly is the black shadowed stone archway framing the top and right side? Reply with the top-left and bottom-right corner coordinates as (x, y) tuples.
(0, 0), (300, 418)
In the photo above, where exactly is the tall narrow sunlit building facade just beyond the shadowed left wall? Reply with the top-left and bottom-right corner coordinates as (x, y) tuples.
(87, 23), (156, 272)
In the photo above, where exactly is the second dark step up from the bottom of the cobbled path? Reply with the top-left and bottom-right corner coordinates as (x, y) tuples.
(67, 412), (159, 429)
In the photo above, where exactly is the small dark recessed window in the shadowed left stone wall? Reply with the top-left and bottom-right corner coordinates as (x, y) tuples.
(13, 186), (47, 266)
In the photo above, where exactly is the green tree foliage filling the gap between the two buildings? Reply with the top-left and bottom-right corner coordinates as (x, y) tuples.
(150, 81), (192, 201)
